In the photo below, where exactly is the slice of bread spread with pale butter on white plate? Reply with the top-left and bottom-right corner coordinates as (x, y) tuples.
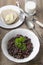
(1, 9), (19, 24)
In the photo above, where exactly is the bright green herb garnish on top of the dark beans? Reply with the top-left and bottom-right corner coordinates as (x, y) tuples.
(14, 36), (27, 51)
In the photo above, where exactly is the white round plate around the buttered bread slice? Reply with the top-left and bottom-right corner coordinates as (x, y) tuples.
(0, 5), (25, 29)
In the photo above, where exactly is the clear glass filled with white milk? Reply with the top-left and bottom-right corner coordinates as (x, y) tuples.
(25, 0), (36, 15)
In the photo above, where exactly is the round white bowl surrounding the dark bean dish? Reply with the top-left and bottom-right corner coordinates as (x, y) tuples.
(1, 28), (40, 63)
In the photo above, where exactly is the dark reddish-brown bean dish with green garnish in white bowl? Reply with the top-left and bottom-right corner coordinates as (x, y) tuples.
(7, 34), (33, 59)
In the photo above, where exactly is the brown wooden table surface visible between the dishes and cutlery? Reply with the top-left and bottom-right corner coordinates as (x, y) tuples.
(0, 0), (43, 65)
